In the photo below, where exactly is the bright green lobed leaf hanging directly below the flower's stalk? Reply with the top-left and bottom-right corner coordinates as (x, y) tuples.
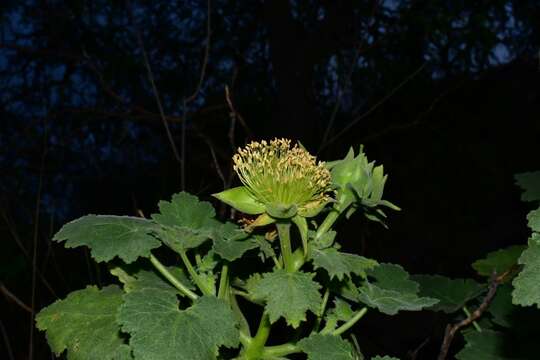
(251, 269), (322, 328)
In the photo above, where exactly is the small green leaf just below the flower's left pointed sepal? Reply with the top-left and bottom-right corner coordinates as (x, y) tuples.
(213, 223), (259, 261)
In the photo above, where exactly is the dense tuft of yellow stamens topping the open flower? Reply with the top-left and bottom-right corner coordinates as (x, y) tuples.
(233, 139), (331, 207)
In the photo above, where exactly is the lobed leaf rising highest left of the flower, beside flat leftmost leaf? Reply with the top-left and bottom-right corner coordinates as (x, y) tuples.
(152, 192), (221, 253)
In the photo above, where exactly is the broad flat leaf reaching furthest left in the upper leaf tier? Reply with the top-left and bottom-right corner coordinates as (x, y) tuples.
(53, 215), (161, 264)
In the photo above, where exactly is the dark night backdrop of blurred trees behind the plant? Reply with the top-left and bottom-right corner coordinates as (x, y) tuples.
(0, 0), (540, 359)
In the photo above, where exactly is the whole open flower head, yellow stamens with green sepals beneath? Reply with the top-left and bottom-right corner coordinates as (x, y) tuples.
(215, 139), (332, 218)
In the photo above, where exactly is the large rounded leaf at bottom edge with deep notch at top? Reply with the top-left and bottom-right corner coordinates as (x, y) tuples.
(118, 273), (239, 360)
